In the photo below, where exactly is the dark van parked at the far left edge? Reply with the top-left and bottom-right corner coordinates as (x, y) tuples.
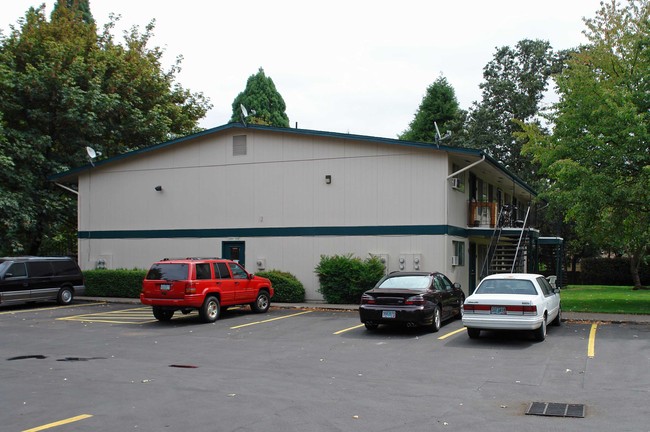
(0, 257), (86, 305)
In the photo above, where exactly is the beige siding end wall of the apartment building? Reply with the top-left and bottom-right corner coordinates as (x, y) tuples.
(79, 130), (467, 300)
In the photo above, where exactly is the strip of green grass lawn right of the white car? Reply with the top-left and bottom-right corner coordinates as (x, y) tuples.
(560, 285), (650, 314)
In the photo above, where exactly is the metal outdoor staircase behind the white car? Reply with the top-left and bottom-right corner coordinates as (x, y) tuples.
(480, 207), (530, 279)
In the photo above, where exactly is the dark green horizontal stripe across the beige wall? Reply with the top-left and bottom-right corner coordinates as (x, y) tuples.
(78, 225), (468, 239)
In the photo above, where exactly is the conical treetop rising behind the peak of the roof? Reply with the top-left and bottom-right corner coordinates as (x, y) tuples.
(230, 68), (289, 127)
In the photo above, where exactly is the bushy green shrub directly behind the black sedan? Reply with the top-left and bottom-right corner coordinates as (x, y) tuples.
(316, 254), (384, 304)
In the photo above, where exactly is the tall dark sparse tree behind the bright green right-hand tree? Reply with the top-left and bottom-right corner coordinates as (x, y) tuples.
(467, 39), (557, 183)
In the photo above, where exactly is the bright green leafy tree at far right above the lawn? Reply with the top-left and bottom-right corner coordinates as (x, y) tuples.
(525, 0), (650, 287)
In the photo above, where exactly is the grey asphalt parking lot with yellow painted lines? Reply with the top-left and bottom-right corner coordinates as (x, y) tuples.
(0, 303), (650, 432)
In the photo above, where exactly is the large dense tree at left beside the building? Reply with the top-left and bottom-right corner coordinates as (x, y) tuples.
(0, 0), (210, 255)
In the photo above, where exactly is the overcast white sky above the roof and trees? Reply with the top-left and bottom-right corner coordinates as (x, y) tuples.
(0, 0), (600, 138)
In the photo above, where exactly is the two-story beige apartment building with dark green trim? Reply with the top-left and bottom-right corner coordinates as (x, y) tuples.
(52, 124), (538, 300)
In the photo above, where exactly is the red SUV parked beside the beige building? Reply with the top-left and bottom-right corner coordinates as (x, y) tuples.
(140, 258), (273, 322)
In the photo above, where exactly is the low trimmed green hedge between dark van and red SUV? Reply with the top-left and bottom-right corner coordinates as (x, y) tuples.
(83, 269), (147, 298)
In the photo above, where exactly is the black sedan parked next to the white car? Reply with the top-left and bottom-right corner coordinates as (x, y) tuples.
(359, 272), (465, 332)
